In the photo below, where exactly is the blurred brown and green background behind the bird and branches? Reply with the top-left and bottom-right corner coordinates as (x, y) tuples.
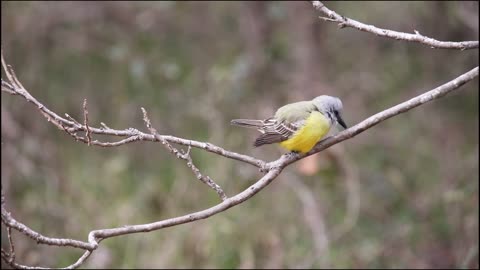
(1, 1), (479, 268)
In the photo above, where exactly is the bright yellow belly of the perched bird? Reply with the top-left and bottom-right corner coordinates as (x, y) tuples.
(280, 111), (330, 153)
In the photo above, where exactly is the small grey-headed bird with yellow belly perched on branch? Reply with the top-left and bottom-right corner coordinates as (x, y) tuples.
(231, 95), (347, 153)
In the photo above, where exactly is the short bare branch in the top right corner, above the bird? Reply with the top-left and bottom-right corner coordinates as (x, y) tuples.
(312, 1), (478, 50)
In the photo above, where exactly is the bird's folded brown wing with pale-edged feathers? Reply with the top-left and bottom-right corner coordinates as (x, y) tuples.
(253, 118), (305, 147)
